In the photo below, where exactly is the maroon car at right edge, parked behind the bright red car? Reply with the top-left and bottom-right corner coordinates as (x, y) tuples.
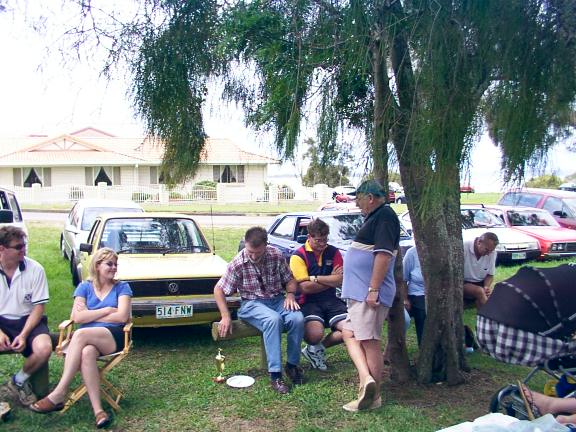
(498, 188), (576, 229)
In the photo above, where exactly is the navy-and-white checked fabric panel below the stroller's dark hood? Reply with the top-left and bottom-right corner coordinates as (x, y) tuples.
(476, 315), (576, 366)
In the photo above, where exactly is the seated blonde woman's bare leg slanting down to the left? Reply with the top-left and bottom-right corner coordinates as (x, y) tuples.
(48, 327), (116, 403)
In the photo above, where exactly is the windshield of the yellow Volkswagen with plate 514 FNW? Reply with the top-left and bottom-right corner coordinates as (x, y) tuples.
(100, 217), (210, 254)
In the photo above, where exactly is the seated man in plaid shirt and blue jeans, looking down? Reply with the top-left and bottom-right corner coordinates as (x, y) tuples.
(214, 227), (304, 394)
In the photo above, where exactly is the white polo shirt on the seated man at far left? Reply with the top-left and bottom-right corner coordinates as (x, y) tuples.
(0, 257), (49, 319)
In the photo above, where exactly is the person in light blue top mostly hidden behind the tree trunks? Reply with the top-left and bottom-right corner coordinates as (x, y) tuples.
(403, 246), (426, 346)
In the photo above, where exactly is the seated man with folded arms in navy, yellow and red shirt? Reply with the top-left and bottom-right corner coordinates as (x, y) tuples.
(290, 219), (348, 371)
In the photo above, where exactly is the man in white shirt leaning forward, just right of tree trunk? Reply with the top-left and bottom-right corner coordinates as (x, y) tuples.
(464, 232), (498, 308)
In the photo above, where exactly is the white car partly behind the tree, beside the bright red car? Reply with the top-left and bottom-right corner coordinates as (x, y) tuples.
(400, 205), (540, 263)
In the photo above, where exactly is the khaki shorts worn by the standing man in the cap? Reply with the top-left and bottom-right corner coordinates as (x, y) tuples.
(344, 300), (390, 340)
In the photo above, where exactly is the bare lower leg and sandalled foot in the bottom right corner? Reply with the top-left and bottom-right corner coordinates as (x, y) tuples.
(519, 383), (576, 424)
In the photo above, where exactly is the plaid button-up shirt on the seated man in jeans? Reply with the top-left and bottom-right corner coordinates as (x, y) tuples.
(216, 246), (294, 300)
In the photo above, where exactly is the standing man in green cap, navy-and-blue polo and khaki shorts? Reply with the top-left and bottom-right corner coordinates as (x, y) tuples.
(342, 180), (400, 412)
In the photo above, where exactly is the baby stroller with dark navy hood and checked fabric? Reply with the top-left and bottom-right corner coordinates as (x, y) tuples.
(477, 264), (576, 420)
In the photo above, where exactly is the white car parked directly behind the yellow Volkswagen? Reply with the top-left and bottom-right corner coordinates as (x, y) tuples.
(60, 199), (144, 286)
